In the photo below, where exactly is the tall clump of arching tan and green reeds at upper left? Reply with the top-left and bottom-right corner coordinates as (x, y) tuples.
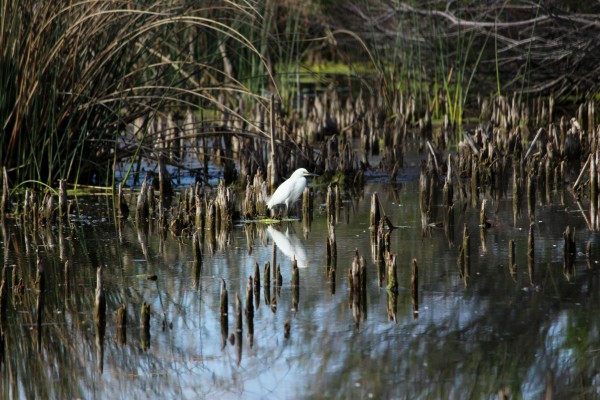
(0, 0), (276, 184)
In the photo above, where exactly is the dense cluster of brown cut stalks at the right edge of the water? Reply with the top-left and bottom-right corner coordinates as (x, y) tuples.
(419, 96), (600, 284)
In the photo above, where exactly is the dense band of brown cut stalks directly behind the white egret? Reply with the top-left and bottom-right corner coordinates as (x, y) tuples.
(124, 82), (414, 192)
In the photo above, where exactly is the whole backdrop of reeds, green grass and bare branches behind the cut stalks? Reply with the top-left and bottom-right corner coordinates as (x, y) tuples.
(0, 0), (597, 191)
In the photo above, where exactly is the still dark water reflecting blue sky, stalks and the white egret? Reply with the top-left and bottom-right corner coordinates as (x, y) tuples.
(0, 181), (600, 399)
